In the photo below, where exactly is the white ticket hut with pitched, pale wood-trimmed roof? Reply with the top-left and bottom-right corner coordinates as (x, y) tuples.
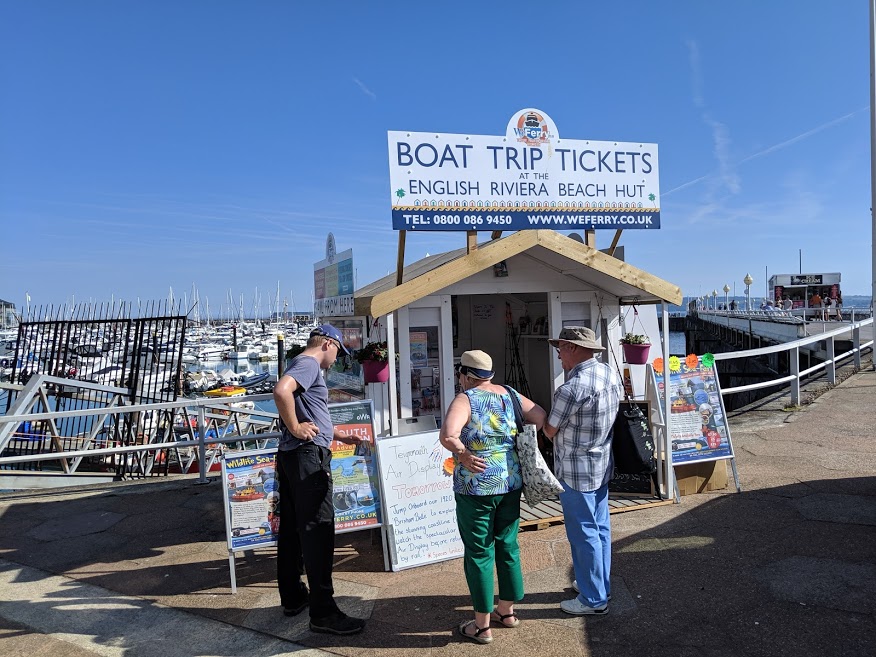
(346, 230), (682, 446)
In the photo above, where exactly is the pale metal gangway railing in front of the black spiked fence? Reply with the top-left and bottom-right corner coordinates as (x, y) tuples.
(0, 375), (281, 481)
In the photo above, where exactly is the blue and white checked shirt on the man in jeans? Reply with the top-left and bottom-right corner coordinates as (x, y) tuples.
(547, 358), (622, 491)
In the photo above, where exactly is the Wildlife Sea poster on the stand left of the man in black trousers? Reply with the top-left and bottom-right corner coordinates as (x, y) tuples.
(222, 449), (280, 552)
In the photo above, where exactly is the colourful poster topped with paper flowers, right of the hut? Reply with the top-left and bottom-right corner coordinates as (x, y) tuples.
(653, 354), (734, 465)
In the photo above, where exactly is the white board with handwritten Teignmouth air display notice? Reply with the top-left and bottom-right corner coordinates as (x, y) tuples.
(377, 431), (463, 571)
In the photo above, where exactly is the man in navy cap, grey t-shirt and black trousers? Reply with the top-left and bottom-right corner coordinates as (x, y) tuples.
(274, 324), (365, 634)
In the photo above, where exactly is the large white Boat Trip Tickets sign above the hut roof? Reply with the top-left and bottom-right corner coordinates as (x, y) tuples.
(389, 108), (660, 230)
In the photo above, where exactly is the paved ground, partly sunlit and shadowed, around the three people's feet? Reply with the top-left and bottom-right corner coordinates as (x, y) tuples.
(0, 477), (876, 657)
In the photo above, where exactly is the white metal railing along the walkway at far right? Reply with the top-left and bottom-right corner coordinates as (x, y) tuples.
(714, 311), (873, 406)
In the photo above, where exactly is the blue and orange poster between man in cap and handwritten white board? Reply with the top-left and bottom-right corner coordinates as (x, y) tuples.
(329, 399), (382, 532)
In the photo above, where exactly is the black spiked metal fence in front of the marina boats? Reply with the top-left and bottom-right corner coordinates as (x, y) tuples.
(2, 302), (186, 476)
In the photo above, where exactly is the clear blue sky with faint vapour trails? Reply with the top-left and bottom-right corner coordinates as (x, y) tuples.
(0, 0), (871, 313)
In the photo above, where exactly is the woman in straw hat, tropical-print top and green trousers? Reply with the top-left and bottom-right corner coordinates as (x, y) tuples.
(441, 350), (546, 643)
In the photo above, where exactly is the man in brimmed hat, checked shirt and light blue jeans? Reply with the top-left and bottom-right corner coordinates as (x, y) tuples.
(544, 326), (622, 616)
